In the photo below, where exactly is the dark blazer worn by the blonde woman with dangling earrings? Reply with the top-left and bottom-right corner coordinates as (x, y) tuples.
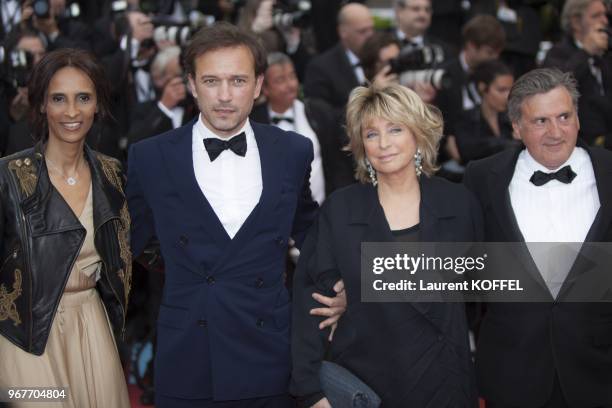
(290, 177), (482, 408)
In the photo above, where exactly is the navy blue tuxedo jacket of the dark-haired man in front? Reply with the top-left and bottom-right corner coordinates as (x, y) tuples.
(127, 121), (317, 400)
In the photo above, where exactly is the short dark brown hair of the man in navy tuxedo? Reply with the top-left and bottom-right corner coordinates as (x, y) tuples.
(183, 22), (266, 76)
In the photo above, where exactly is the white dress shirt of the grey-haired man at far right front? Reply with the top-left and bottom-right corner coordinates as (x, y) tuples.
(509, 147), (600, 297)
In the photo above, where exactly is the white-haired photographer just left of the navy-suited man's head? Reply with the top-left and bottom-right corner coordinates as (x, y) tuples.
(127, 46), (195, 144)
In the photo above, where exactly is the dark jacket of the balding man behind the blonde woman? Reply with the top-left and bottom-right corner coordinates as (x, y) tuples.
(304, 43), (359, 112)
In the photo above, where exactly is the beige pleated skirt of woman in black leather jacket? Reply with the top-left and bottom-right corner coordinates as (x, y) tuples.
(0, 289), (130, 408)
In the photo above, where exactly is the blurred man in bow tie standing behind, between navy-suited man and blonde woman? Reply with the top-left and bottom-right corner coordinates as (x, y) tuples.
(250, 52), (355, 199)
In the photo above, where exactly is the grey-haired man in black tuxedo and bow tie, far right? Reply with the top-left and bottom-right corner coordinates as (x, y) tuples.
(464, 69), (612, 408)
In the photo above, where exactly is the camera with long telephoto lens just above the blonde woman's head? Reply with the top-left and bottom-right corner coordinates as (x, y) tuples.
(389, 45), (451, 90)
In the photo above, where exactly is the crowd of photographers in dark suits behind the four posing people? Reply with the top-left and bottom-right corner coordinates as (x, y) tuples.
(0, 0), (612, 181)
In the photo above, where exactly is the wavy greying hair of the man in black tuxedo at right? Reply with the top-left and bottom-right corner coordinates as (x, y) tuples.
(508, 68), (580, 123)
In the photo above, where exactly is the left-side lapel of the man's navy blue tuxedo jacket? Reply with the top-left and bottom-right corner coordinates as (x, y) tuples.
(160, 119), (230, 244)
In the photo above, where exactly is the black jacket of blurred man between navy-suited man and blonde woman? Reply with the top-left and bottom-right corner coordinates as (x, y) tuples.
(251, 100), (355, 196)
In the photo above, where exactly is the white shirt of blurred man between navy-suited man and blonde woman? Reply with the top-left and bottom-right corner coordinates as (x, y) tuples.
(268, 99), (325, 204)
